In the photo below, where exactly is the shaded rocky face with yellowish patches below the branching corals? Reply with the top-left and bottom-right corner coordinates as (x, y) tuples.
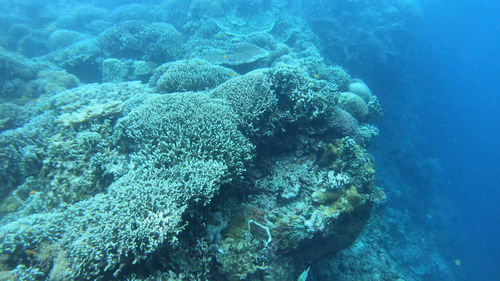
(211, 135), (374, 280)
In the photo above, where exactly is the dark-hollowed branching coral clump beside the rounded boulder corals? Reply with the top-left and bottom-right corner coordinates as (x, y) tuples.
(212, 66), (348, 142)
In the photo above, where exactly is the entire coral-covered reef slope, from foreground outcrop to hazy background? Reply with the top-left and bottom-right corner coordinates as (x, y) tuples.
(0, 0), (456, 281)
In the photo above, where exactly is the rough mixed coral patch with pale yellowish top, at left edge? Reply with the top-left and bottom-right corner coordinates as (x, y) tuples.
(0, 82), (147, 214)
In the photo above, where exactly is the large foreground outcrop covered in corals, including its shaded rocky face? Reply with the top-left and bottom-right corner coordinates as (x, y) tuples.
(0, 60), (382, 280)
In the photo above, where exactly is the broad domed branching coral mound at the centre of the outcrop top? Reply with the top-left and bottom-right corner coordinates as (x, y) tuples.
(113, 92), (253, 177)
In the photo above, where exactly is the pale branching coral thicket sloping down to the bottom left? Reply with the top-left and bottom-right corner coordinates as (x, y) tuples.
(0, 158), (226, 279)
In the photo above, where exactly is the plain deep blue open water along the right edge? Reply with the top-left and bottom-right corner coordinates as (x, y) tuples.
(408, 0), (500, 281)
